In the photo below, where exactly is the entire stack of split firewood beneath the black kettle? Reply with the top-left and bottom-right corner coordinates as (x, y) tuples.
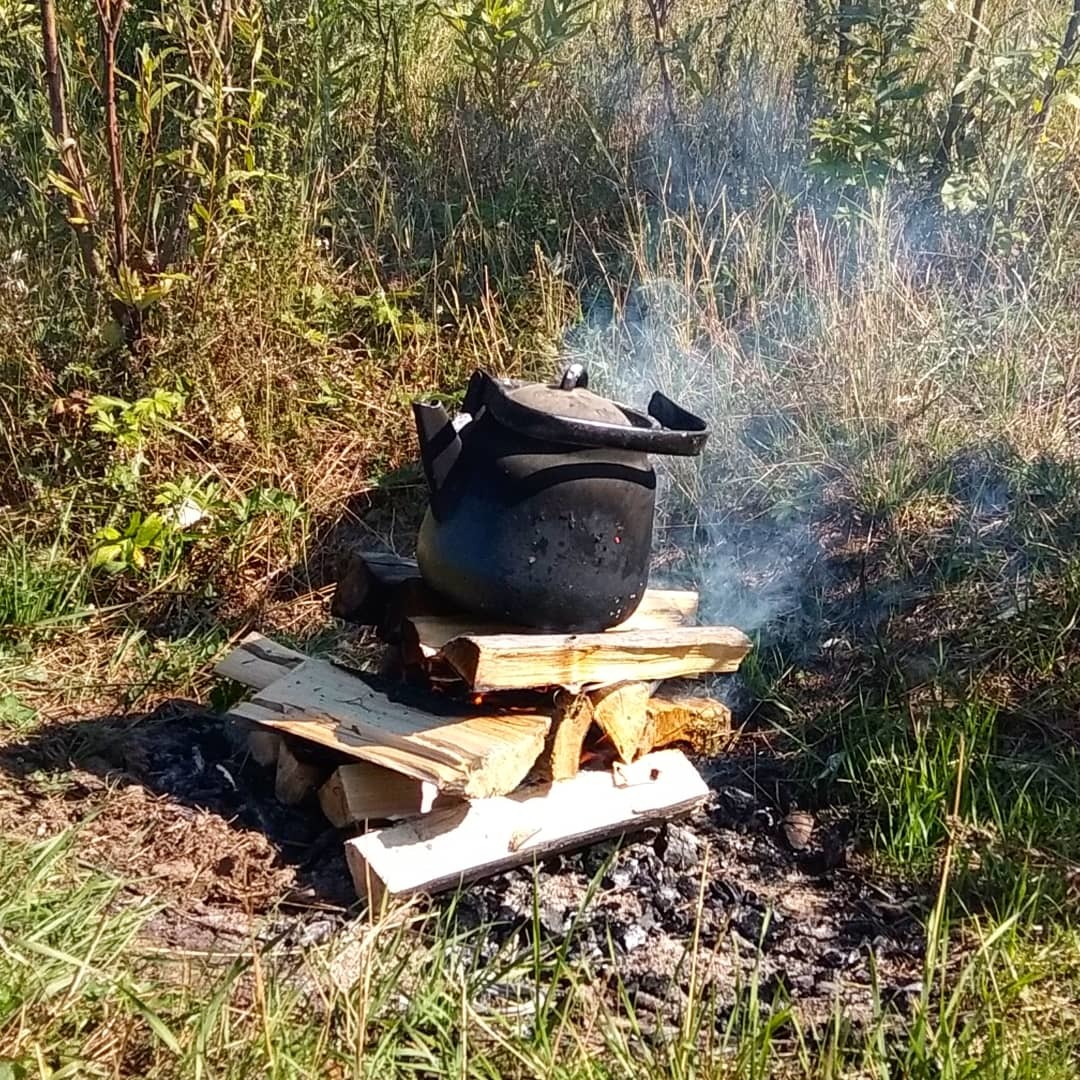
(216, 555), (751, 903)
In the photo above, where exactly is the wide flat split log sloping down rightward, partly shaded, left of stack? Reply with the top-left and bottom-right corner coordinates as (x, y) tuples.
(231, 660), (551, 798)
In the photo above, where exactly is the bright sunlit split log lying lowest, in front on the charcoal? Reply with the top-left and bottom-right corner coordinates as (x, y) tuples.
(346, 750), (708, 907)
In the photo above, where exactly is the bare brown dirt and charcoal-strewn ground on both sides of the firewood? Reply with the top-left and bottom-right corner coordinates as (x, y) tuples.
(0, 701), (923, 1030)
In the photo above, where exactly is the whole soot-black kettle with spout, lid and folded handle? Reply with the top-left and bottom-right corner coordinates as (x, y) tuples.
(413, 364), (708, 632)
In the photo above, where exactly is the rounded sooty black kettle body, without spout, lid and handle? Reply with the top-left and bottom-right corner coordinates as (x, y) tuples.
(417, 413), (656, 632)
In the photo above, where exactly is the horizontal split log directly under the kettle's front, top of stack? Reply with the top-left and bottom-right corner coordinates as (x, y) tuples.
(440, 626), (751, 692)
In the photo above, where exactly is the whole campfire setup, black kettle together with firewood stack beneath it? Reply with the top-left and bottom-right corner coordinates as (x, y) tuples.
(210, 369), (751, 903)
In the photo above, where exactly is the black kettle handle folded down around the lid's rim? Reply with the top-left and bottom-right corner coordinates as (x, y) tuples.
(481, 373), (708, 458)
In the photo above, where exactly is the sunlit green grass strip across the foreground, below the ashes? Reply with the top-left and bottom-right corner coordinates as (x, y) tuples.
(0, 834), (1080, 1080)
